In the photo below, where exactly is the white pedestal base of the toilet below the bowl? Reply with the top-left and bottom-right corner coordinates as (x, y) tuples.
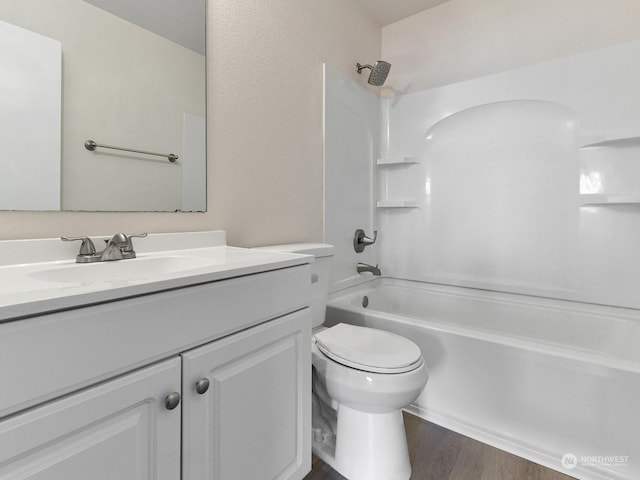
(313, 405), (411, 480)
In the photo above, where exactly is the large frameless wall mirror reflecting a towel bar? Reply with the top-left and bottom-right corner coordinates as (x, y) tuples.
(0, 0), (206, 212)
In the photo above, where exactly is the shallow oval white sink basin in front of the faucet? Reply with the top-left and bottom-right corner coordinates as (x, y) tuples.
(30, 255), (215, 284)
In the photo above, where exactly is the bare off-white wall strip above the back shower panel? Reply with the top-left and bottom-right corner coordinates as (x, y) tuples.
(382, 0), (640, 96)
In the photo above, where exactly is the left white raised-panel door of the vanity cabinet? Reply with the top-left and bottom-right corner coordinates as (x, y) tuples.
(0, 358), (181, 480)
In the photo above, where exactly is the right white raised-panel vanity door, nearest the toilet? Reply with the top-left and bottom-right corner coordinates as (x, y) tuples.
(182, 308), (311, 480)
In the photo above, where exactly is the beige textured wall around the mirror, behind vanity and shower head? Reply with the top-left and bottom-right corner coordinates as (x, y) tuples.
(0, 0), (380, 246)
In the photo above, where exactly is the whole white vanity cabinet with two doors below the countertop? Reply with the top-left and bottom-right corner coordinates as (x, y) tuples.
(0, 264), (311, 480)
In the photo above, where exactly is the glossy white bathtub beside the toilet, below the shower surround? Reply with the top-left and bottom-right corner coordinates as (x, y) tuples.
(326, 279), (640, 480)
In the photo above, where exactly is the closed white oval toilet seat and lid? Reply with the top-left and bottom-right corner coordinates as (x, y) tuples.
(313, 323), (424, 373)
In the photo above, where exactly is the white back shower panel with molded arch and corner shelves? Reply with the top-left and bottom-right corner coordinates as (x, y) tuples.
(377, 42), (640, 308)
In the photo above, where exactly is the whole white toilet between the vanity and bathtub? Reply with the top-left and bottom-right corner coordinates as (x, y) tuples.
(254, 243), (428, 480)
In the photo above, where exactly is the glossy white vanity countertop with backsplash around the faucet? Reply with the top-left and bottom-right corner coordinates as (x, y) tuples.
(0, 231), (313, 322)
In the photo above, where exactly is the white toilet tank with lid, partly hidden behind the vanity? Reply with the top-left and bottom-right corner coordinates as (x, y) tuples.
(256, 243), (335, 328)
